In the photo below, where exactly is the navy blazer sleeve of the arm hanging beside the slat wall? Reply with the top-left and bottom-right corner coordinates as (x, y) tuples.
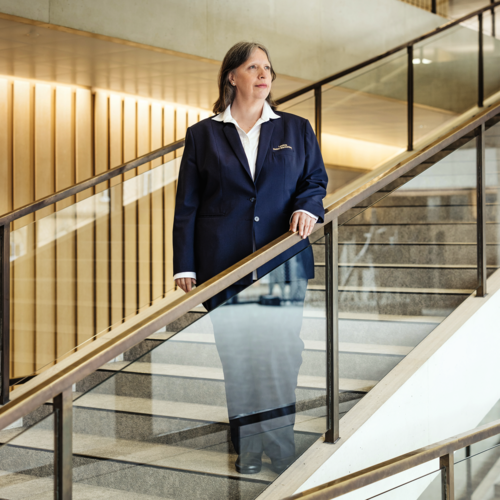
(173, 128), (201, 275)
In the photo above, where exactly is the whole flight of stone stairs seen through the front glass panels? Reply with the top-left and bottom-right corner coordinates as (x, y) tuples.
(0, 122), (500, 499)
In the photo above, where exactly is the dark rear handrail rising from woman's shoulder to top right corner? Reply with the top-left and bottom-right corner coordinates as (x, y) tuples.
(275, 1), (500, 105)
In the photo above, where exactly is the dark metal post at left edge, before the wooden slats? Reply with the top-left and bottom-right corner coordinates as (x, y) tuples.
(0, 224), (10, 405)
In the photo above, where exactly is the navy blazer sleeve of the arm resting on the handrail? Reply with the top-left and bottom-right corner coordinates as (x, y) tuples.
(292, 120), (328, 223)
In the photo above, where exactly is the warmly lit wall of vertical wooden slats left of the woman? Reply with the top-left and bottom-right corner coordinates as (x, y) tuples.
(0, 78), (210, 378)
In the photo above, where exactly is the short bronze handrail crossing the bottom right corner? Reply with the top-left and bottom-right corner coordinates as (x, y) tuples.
(284, 420), (500, 500)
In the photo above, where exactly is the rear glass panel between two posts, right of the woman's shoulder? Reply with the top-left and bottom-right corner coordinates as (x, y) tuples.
(321, 52), (408, 181)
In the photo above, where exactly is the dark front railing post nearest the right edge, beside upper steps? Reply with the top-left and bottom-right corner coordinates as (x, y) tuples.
(476, 123), (487, 297)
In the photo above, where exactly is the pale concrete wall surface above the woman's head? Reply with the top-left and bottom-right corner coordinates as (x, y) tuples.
(0, 0), (445, 80)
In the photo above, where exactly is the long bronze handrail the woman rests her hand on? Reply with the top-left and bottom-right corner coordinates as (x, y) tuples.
(0, 98), (500, 429)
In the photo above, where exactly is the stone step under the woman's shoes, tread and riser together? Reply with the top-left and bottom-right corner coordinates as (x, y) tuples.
(0, 429), (277, 498)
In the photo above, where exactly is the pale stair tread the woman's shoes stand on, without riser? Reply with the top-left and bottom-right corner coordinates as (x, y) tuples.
(0, 429), (277, 482)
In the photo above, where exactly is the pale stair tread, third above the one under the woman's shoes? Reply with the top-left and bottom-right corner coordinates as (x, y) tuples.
(160, 332), (412, 356)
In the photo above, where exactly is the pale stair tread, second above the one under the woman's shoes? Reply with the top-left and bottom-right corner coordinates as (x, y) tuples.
(100, 361), (377, 392)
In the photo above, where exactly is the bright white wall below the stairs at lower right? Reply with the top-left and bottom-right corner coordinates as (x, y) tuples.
(299, 272), (500, 500)
